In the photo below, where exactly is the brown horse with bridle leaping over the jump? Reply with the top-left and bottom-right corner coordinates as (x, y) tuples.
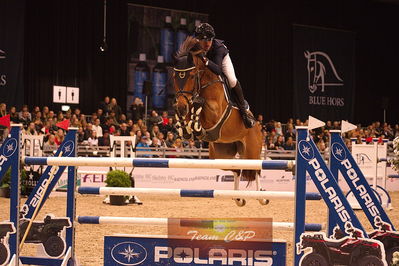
(172, 37), (262, 204)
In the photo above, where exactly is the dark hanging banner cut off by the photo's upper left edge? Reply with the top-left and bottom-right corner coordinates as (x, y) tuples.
(0, 0), (25, 107)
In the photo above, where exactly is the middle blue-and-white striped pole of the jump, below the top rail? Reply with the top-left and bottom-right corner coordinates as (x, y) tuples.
(78, 187), (321, 200)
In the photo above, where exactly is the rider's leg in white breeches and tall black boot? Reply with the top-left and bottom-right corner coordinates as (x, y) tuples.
(222, 54), (255, 128)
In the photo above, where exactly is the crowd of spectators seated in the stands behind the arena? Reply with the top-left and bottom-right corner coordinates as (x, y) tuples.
(0, 100), (399, 156)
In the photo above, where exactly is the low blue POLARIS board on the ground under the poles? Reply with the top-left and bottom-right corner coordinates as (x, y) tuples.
(104, 236), (286, 266)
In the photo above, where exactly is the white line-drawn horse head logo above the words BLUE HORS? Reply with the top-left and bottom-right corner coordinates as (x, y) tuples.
(304, 51), (344, 93)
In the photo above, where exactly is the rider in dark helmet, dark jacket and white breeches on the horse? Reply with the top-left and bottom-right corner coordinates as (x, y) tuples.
(195, 23), (256, 128)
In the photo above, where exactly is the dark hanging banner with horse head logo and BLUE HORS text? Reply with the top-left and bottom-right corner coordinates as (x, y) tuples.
(293, 25), (355, 121)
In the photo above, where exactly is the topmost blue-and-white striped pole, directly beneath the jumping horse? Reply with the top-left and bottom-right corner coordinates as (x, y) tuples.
(22, 157), (295, 170)
